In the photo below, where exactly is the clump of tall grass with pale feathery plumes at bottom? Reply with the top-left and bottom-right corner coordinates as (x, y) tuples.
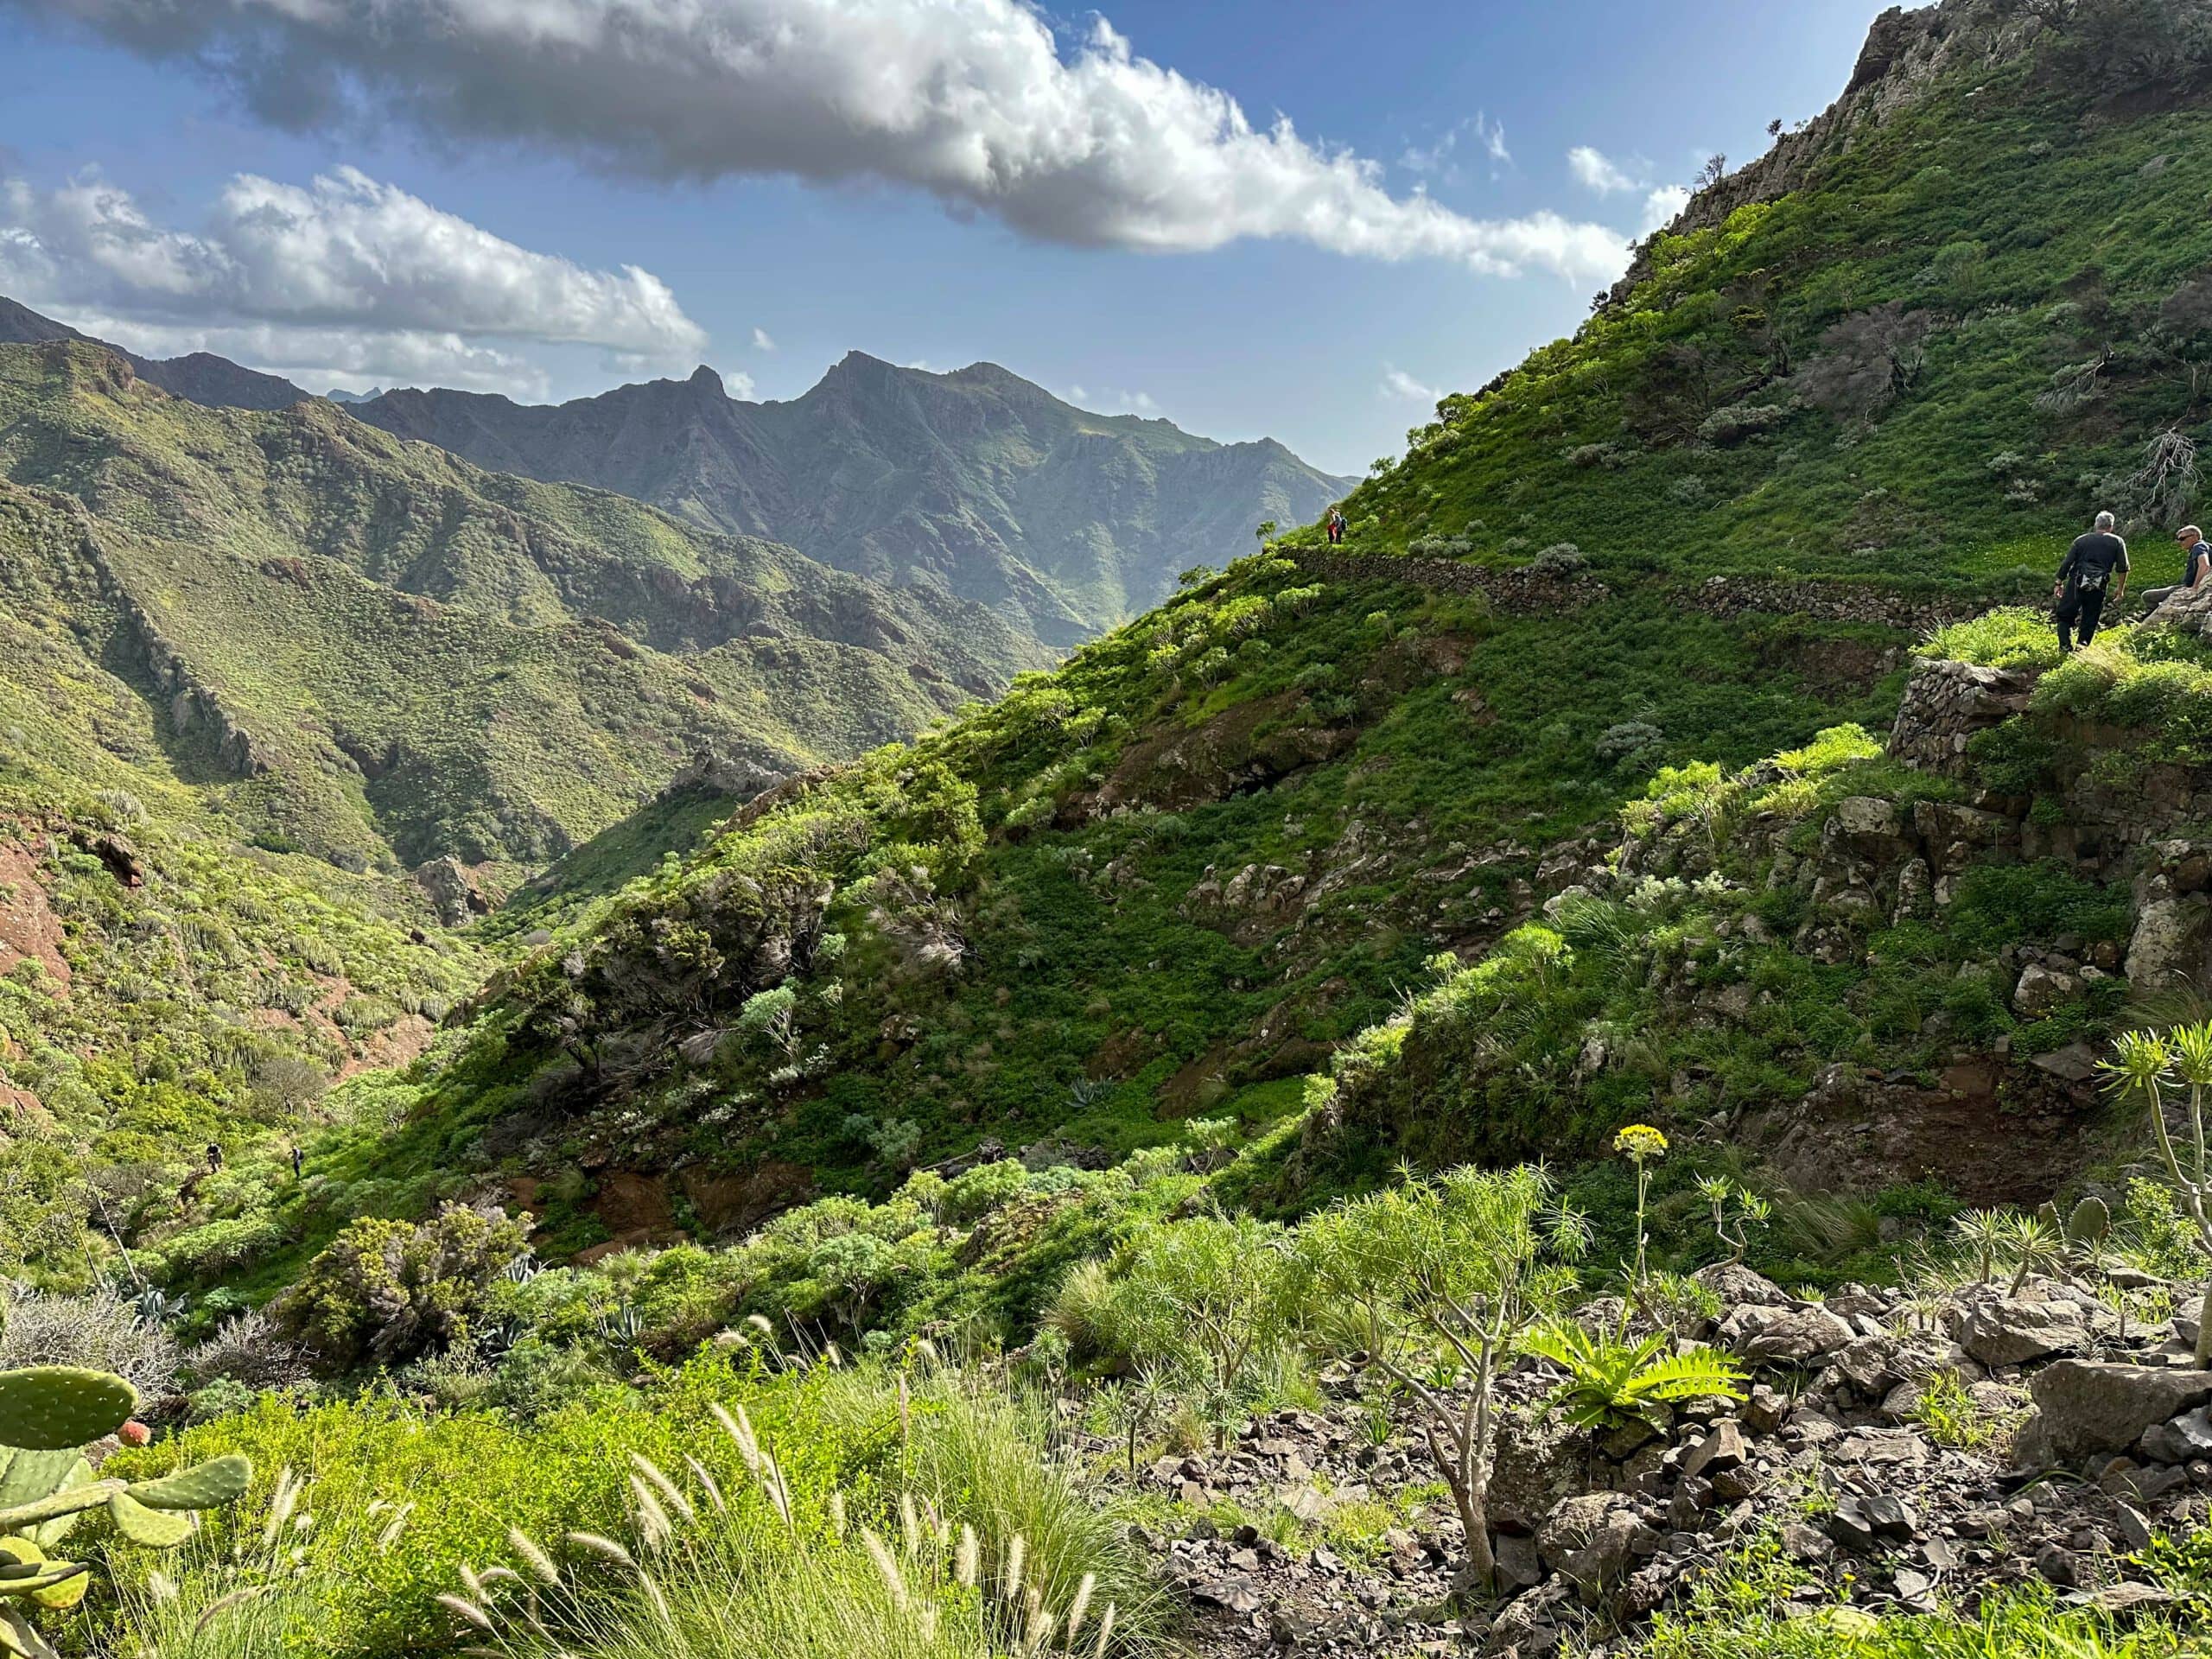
(442, 1371), (1166, 1659)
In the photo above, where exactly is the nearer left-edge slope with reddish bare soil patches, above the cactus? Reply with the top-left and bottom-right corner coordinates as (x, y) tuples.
(0, 485), (486, 1274)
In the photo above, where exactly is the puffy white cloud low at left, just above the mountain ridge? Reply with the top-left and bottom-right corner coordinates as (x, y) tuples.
(0, 168), (706, 391)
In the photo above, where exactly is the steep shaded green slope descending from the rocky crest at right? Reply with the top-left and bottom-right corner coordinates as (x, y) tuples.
(285, 0), (2212, 1241)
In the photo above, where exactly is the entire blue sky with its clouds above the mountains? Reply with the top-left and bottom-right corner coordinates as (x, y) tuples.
(0, 0), (1883, 474)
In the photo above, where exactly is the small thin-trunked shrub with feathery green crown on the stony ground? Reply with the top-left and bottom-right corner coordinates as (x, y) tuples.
(1299, 1168), (1588, 1586)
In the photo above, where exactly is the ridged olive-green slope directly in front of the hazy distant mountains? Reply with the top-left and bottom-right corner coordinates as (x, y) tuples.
(0, 343), (1038, 882)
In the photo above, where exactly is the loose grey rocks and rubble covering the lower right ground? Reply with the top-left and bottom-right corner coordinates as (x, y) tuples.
(1093, 1268), (2212, 1659)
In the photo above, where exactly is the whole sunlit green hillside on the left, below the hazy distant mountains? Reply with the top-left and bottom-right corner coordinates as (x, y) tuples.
(0, 340), (1038, 1272)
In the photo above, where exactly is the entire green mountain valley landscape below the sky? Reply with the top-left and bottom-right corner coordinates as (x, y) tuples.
(0, 0), (2212, 1659)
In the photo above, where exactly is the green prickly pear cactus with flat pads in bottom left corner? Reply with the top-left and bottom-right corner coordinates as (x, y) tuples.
(0, 1365), (254, 1659)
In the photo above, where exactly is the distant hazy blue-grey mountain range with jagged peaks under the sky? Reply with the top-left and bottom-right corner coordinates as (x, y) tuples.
(356, 352), (1350, 648)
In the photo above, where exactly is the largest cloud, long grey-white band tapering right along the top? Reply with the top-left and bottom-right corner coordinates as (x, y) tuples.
(0, 0), (1626, 281)
